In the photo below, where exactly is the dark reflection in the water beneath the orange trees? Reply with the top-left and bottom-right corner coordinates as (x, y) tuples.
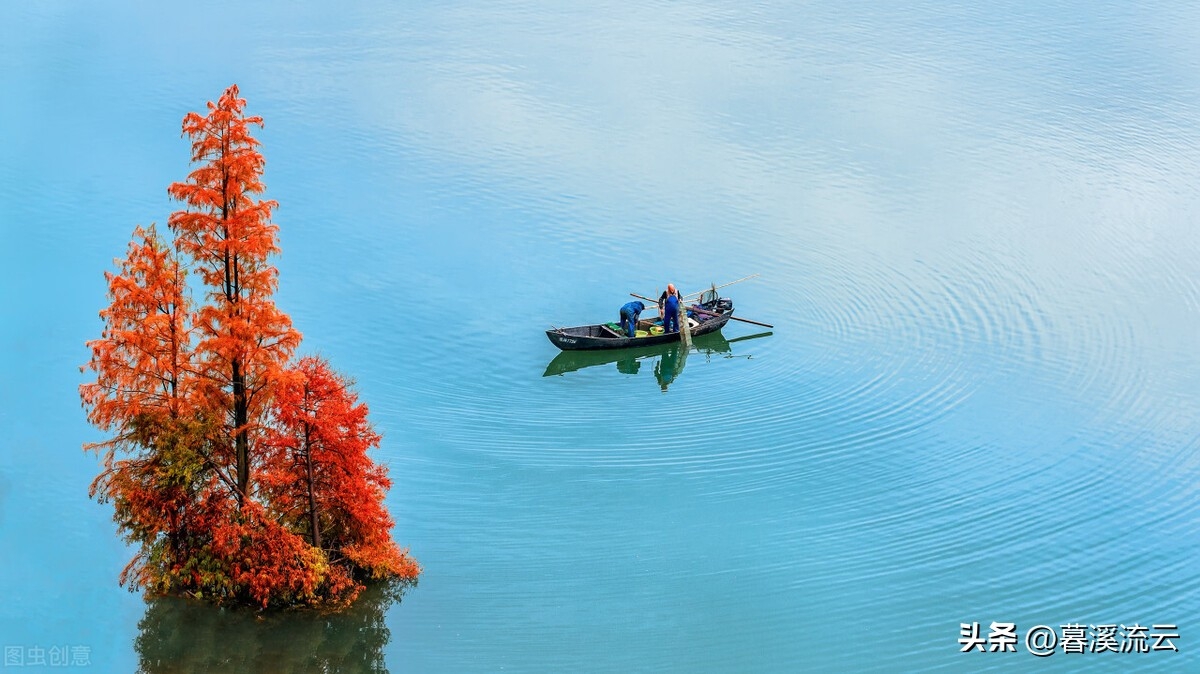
(133, 583), (409, 674)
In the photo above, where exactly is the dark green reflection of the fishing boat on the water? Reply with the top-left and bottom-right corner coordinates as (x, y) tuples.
(542, 332), (773, 391)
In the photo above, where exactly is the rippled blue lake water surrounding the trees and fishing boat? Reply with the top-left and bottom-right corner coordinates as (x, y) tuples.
(0, 1), (1200, 672)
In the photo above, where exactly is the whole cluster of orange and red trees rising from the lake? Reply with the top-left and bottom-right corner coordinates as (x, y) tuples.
(80, 86), (420, 607)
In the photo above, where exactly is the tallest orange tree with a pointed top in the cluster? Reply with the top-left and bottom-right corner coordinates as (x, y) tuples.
(168, 85), (300, 504)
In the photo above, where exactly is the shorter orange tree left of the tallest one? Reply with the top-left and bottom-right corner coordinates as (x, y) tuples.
(79, 225), (218, 586)
